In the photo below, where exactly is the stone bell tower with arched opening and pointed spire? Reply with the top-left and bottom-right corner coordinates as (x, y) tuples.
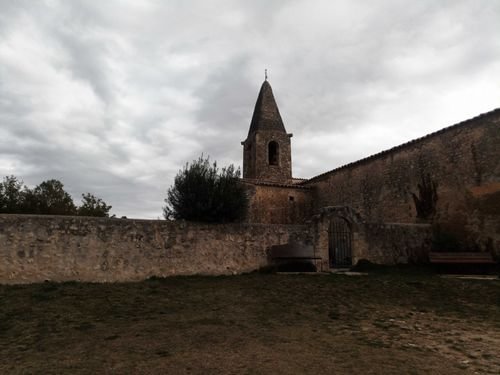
(241, 77), (292, 184)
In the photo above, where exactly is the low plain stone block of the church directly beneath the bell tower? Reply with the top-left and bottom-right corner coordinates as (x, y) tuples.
(243, 180), (312, 224)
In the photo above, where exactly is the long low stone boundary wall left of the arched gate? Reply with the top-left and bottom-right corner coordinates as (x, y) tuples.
(0, 214), (308, 284)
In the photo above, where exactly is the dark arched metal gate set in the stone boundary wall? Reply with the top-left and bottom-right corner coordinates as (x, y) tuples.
(328, 217), (352, 267)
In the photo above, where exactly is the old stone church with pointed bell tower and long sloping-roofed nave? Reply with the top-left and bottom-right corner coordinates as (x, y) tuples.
(241, 79), (500, 263)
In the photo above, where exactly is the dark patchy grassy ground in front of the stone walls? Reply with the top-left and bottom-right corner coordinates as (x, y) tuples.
(0, 269), (500, 374)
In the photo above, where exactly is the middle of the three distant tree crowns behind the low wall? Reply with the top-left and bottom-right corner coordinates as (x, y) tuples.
(26, 180), (77, 215)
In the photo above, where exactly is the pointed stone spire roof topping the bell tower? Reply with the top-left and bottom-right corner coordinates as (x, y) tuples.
(248, 77), (286, 135)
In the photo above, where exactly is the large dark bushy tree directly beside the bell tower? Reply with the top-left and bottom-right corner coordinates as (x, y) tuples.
(163, 155), (248, 222)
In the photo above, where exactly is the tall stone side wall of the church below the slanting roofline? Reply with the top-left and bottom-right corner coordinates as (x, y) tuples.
(304, 110), (500, 255)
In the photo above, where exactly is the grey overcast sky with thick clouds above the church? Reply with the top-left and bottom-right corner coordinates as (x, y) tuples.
(0, 0), (500, 218)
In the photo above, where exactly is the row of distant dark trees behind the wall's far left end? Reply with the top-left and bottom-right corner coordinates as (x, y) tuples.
(0, 176), (111, 217)
